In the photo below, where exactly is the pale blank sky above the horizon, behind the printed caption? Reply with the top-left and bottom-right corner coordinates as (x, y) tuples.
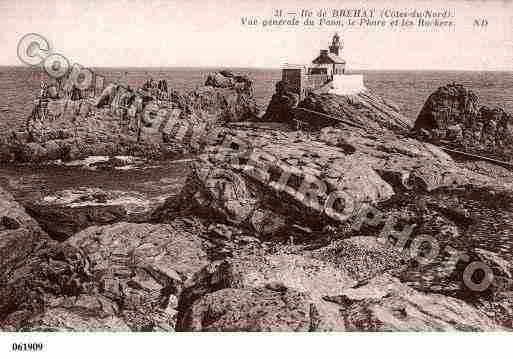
(0, 0), (513, 71)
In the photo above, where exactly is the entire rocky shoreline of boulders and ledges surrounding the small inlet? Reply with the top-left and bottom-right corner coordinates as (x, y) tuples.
(0, 73), (513, 331)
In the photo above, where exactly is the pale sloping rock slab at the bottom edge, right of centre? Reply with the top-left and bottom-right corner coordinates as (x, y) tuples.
(325, 275), (502, 331)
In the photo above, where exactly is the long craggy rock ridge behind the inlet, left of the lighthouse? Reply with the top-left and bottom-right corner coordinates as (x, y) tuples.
(0, 74), (258, 162)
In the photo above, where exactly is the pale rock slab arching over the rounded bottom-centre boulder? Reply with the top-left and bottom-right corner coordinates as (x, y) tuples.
(178, 254), (356, 330)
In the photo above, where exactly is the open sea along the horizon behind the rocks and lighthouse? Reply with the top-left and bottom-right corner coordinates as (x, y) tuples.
(0, 66), (513, 131)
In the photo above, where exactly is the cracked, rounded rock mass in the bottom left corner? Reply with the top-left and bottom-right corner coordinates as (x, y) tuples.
(0, 223), (212, 331)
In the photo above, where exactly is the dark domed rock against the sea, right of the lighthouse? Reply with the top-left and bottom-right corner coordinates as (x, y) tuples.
(415, 84), (513, 161)
